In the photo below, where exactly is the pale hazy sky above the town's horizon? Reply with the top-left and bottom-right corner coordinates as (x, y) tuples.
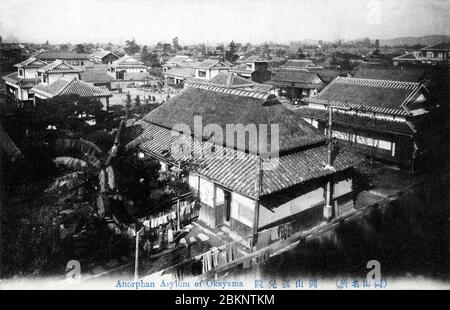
(0, 0), (450, 45)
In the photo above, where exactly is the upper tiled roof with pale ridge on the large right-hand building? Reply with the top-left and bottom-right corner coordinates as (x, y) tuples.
(306, 77), (421, 115)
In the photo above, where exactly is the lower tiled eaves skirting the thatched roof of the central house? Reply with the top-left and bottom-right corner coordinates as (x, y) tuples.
(128, 120), (362, 197)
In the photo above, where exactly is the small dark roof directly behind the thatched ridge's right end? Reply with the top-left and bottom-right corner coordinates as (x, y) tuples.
(264, 70), (323, 89)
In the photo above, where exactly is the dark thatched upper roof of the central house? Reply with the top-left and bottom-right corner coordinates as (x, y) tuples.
(145, 85), (325, 152)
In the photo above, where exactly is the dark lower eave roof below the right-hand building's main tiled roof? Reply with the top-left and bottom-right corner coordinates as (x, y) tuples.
(292, 106), (415, 136)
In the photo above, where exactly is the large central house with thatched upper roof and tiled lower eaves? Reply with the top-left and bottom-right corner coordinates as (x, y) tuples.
(125, 83), (361, 247)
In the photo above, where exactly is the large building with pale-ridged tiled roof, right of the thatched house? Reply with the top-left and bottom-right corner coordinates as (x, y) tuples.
(296, 77), (428, 168)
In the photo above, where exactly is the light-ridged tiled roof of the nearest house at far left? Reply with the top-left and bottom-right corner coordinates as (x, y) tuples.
(31, 78), (112, 98)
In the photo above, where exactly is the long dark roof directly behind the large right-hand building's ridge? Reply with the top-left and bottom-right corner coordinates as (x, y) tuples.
(354, 67), (425, 82)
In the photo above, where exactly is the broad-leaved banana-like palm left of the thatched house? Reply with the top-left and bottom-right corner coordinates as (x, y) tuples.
(47, 120), (149, 218)
